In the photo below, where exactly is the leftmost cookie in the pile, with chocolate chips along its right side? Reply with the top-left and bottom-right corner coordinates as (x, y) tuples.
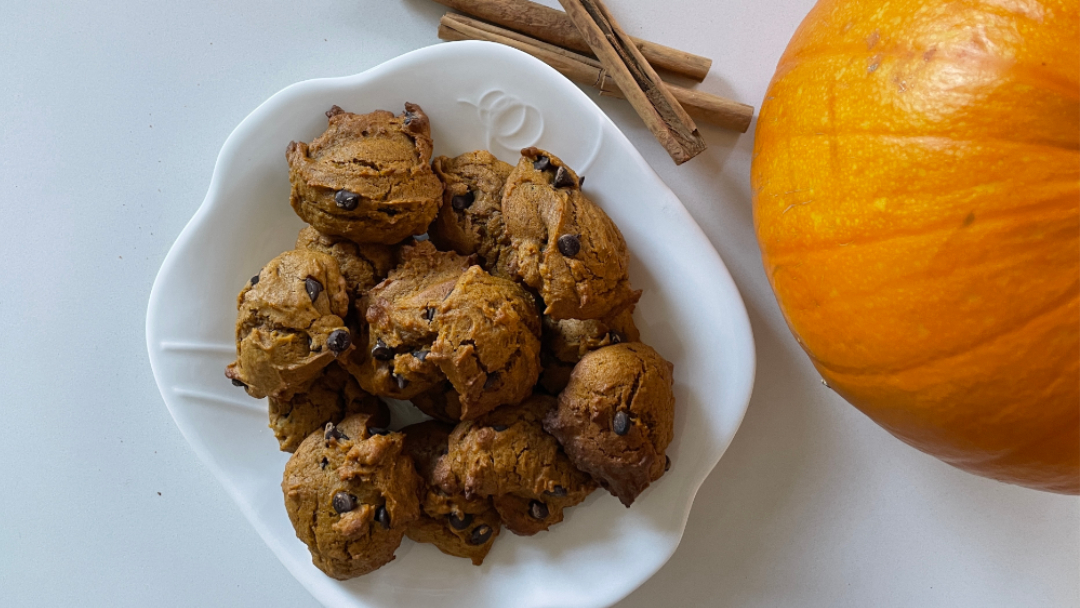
(225, 251), (353, 400)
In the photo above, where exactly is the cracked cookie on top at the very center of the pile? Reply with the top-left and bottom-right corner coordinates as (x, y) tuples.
(428, 266), (540, 420)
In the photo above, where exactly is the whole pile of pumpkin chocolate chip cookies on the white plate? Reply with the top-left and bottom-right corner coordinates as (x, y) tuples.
(226, 104), (674, 579)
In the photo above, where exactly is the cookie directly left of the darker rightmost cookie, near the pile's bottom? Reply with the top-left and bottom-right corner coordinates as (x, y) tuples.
(434, 395), (596, 536)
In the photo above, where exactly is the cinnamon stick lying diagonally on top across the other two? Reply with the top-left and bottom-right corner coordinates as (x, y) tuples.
(558, 0), (705, 164)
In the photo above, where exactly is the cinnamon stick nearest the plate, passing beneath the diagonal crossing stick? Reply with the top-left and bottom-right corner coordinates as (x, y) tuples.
(438, 13), (754, 133)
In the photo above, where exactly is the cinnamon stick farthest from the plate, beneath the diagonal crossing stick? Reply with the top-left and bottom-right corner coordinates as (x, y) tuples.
(425, 0), (713, 82)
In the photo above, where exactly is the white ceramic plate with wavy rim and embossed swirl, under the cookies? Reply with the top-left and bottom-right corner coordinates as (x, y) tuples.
(146, 42), (754, 608)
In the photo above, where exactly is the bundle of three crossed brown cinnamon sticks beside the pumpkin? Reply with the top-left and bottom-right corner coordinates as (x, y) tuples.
(427, 0), (754, 164)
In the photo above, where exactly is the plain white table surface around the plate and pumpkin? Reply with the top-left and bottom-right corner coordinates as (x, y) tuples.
(0, 0), (1080, 608)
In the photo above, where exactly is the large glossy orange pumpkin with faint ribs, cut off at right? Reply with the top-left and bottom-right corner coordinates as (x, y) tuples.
(752, 0), (1080, 494)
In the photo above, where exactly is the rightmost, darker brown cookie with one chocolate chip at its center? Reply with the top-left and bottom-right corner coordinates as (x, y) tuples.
(543, 342), (675, 506)
